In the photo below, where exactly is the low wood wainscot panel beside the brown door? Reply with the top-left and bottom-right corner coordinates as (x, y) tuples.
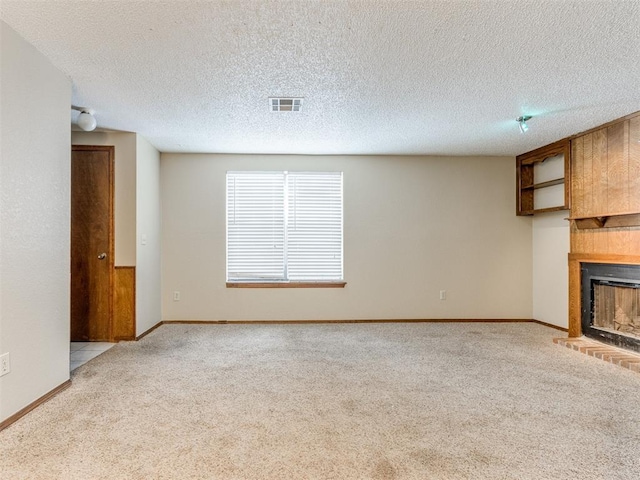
(112, 267), (136, 342)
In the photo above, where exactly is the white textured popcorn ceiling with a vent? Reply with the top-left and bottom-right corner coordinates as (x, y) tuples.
(0, 0), (640, 155)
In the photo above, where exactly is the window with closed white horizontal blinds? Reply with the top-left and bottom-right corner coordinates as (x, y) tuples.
(227, 172), (343, 284)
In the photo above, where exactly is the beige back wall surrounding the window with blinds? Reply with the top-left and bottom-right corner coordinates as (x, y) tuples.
(160, 154), (532, 320)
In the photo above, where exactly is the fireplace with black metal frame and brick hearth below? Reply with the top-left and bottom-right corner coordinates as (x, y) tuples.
(580, 263), (640, 353)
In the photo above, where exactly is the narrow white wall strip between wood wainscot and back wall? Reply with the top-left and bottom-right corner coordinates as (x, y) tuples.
(136, 135), (162, 335)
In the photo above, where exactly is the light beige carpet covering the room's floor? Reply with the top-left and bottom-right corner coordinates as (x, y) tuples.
(0, 323), (640, 480)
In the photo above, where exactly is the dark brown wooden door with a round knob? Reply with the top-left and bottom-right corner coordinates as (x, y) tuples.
(71, 145), (114, 342)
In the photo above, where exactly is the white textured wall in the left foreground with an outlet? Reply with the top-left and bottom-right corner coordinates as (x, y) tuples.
(0, 21), (71, 421)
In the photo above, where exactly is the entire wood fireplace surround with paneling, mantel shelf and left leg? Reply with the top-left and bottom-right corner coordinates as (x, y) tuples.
(569, 112), (640, 337)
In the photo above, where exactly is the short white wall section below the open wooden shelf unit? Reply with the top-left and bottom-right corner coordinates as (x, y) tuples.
(533, 212), (569, 328)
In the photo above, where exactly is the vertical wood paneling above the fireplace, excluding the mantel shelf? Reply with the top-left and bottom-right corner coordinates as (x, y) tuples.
(571, 114), (640, 255)
